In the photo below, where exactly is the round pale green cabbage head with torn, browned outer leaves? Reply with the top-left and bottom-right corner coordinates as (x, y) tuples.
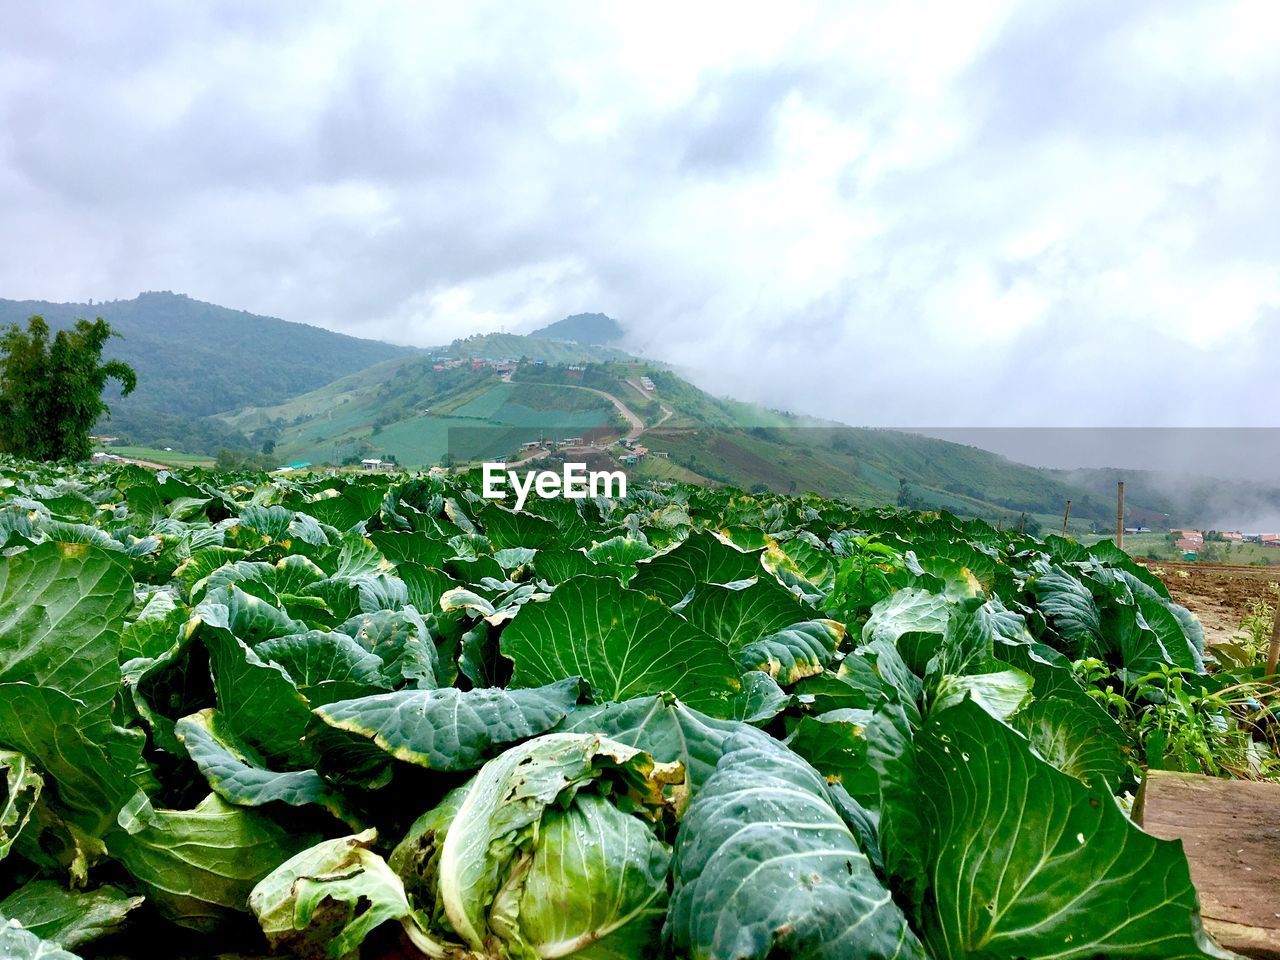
(390, 733), (684, 960)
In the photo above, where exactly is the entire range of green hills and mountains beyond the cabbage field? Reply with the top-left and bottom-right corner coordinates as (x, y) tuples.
(0, 293), (1280, 532)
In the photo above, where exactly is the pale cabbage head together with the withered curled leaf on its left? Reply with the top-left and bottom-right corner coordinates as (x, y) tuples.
(250, 733), (684, 960)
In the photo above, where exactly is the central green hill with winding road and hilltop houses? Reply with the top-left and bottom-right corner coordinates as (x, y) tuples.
(221, 343), (1112, 530)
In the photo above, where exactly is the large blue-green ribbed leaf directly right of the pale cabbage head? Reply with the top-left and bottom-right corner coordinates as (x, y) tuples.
(666, 739), (925, 960)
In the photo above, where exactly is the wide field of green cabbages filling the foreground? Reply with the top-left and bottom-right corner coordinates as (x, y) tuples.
(0, 462), (1274, 960)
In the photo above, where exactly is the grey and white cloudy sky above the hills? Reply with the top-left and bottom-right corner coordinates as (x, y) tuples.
(0, 0), (1280, 426)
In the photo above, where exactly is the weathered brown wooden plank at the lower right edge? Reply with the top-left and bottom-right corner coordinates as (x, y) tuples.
(1134, 771), (1280, 960)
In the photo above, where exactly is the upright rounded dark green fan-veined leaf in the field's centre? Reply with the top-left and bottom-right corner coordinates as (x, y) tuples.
(500, 577), (741, 716)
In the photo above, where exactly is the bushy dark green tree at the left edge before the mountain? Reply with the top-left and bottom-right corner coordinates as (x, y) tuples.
(0, 316), (138, 460)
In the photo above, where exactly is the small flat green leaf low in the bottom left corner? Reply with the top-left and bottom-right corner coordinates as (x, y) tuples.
(0, 879), (142, 950)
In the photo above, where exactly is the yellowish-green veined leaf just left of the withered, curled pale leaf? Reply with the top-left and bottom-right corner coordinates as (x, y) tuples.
(108, 794), (317, 932)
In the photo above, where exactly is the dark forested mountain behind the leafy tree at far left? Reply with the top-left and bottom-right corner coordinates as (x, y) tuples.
(0, 292), (415, 452)
